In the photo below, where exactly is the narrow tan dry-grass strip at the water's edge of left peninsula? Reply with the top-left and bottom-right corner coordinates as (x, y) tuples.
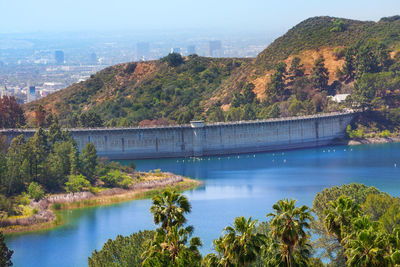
(0, 178), (200, 235)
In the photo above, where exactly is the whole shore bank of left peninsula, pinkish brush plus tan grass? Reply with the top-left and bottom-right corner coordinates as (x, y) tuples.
(0, 175), (201, 235)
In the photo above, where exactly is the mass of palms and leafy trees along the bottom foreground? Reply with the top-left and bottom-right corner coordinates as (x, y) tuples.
(89, 184), (400, 266)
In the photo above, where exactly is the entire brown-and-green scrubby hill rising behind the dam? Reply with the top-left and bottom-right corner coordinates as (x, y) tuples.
(25, 16), (400, 130)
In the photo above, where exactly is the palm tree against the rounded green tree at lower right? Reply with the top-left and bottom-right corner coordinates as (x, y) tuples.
(324, 196), (360, 244)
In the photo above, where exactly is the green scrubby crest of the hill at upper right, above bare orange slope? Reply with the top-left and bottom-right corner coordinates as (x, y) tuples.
(257, 16), (400, 68)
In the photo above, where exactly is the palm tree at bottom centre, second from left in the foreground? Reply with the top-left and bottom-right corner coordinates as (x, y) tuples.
(204, 217), (264, 267)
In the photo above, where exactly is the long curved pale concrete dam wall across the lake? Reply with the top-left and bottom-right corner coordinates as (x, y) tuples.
(0, 113), (355, 159)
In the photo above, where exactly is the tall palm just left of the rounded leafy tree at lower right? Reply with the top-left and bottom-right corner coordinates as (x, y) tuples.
(267, 199), (313, 267)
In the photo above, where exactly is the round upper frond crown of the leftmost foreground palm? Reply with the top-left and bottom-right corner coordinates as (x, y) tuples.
(150, 189), (192, 231)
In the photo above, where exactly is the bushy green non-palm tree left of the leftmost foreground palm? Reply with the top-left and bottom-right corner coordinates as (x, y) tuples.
(88, 231), (155, 267)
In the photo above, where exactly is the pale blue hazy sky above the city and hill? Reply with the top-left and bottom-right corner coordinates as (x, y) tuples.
(0, 0), (400, 33)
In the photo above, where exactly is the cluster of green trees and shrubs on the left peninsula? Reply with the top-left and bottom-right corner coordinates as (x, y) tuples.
(0, 120), (139, 223)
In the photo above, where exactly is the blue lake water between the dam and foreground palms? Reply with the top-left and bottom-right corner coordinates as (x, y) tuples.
(6, 143), (400, 267)
